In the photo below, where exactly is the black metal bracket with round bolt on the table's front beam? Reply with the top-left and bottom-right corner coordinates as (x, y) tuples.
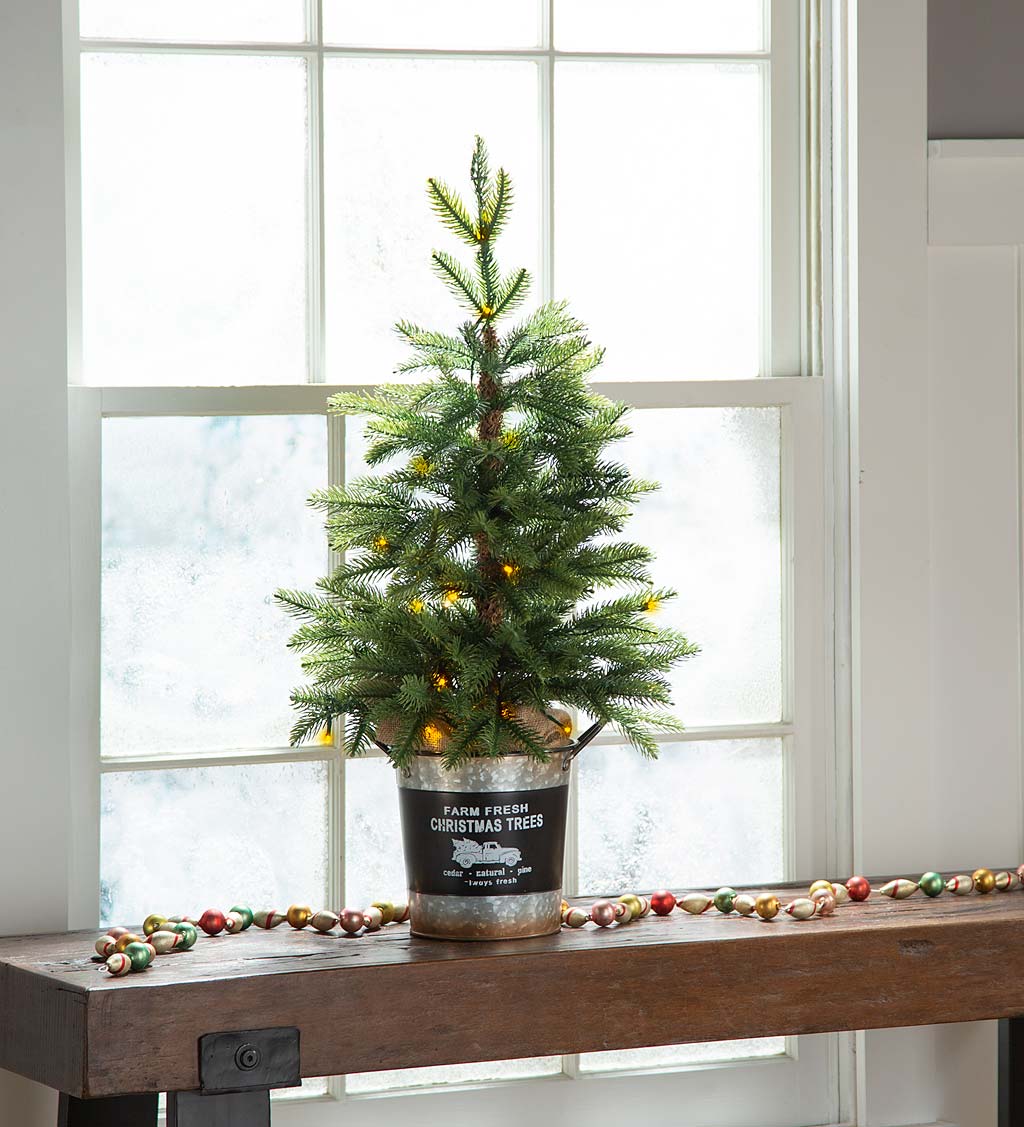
(199, 1026), (302, 1093)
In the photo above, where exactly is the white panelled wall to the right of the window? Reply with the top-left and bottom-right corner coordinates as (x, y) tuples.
(851, 8), (1024, 1127)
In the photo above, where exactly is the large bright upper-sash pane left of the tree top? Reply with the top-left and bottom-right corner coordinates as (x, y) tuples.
(82, 53), (306, 384)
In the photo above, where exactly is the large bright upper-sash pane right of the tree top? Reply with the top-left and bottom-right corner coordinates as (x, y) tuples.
(554, 63), (764, 380)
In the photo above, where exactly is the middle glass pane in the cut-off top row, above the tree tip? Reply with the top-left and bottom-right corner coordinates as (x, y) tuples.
(323, 0), (541, 50)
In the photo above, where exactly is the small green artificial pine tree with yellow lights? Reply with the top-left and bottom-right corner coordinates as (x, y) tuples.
(277, 137), (696, 765)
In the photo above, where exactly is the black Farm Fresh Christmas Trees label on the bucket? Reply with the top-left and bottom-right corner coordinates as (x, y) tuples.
(399, 787), (569, 896)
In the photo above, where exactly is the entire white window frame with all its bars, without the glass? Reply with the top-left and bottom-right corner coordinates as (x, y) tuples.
(65, 0), (840, 1122)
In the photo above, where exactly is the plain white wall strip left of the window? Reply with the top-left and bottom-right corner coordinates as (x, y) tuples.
(0, 0), (69, 1127)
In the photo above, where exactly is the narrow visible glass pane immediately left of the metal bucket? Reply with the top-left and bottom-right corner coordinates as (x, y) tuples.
(345, 757), (408, 908)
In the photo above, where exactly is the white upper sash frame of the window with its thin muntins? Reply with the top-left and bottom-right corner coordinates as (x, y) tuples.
(66, 0), (812, 385)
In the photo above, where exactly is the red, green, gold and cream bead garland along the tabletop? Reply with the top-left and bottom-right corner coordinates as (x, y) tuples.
(96, 864), (1024, 976)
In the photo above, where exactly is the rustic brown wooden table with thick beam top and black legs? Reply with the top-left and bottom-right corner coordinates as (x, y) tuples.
(0, 881), (1024, 1127)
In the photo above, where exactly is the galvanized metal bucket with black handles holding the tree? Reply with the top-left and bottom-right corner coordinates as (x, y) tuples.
(381, 724), (603, 940)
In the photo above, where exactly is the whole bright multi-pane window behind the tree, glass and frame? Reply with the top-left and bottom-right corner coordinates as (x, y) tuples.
(65, 0), (836, 1124)
